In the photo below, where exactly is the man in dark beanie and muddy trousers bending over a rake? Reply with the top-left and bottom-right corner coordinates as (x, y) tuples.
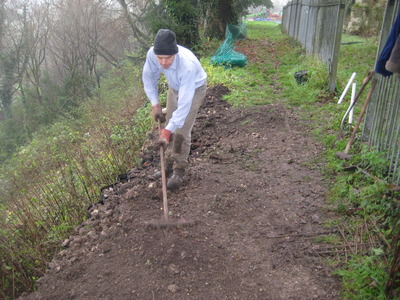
(142, 29), (207, 190)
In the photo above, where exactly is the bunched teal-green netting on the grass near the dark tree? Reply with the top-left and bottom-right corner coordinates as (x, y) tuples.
(211, 23), (247, 67)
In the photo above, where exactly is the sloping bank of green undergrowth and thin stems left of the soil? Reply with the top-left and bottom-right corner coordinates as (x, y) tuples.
(0, 62), (152, 298)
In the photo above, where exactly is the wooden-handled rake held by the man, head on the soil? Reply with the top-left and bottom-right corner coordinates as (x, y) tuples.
(145, 119), (194, 228)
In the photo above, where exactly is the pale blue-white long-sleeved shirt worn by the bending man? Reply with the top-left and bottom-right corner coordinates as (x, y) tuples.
(142, 45), (207, 132)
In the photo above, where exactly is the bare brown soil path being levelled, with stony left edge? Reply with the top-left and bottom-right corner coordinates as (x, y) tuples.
(20, 86), (341, 300)
